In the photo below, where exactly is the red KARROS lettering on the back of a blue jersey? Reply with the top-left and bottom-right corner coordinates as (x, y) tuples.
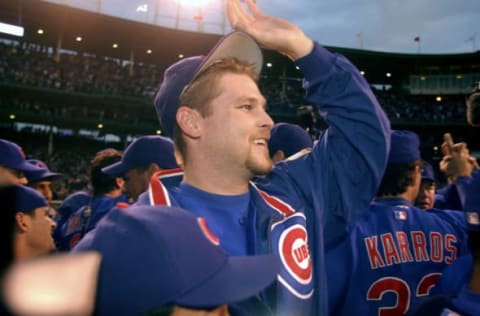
(364, 231), (457, 269)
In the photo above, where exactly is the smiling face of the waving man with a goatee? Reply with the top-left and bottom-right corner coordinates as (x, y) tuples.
(199, 73), (273, 178)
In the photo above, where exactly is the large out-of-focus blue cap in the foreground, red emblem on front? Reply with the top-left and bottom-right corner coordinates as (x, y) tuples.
(73, 206), (279, 315)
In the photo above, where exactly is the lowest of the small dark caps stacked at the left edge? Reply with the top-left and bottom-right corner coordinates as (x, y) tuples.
(5, 185), (48, 213)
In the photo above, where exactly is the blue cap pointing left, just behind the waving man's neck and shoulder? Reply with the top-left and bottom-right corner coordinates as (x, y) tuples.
(102, 135), (178, 176)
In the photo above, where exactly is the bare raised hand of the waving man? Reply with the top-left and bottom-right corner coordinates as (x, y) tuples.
(227, 0), (313, 60)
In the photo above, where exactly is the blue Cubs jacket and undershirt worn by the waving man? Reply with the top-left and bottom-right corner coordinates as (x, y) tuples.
(137, 43), (390, 315)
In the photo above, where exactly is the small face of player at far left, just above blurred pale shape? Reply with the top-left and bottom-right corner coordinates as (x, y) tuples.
(25, 206), (56, 255)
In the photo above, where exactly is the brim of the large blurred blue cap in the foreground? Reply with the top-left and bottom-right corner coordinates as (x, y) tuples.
(175, 255), (279, 308)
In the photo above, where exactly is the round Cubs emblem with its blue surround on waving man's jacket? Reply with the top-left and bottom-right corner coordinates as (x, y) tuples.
(272, 213), (313, 299)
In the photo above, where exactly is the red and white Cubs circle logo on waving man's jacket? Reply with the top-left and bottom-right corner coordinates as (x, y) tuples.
(278, 225), (312, 284)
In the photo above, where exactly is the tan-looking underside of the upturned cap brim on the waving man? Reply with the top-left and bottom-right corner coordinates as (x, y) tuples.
(190, 31), (263, 82)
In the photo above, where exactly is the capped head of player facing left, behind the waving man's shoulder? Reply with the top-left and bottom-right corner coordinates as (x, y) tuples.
(102, 136), (178, 202)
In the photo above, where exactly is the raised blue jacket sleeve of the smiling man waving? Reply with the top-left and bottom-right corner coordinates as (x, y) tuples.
(262, 43), (390, 242)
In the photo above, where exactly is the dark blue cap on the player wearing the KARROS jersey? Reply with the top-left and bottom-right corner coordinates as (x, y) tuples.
(388, 130), (422, 165)
